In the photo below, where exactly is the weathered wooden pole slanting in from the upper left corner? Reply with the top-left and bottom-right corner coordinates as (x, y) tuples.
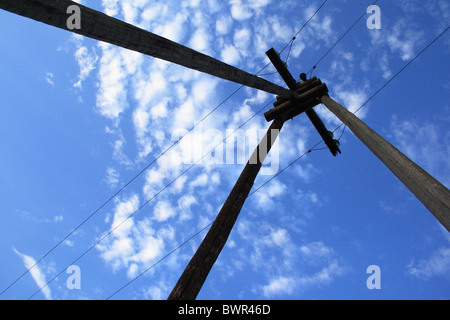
(0, 0), (289, 95)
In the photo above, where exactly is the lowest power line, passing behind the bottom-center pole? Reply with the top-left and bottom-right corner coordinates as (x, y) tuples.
(102, 27), (449, 300)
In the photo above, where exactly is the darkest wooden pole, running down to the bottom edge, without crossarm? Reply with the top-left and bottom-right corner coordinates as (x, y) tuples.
(168, 120), (284, 300)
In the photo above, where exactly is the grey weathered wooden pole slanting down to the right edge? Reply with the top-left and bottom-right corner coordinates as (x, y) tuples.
(320, 95), (450, 231)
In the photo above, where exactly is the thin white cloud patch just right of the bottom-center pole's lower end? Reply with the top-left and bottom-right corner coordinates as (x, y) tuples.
(234, 215), (344, 299)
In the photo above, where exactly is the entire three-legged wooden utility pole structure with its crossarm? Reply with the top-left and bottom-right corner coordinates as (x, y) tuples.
(5, 0), (450, 300)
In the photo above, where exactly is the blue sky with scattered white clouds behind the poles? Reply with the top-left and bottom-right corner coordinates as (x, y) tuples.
(0, 0), (450, 299)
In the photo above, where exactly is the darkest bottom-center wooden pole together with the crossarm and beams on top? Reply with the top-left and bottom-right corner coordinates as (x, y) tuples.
(168, 49), (334, 300)
